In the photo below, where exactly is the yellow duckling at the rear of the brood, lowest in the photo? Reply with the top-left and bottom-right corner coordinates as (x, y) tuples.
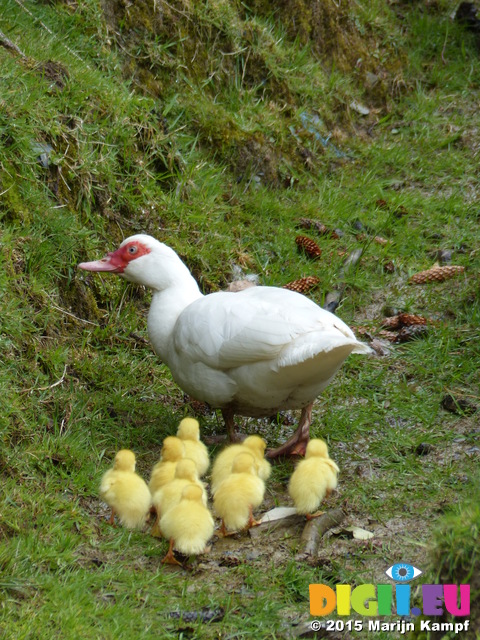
(160, 484), (215, 564)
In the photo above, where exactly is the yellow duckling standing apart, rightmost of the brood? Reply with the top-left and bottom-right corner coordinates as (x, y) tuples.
(288, 438), (339, 518)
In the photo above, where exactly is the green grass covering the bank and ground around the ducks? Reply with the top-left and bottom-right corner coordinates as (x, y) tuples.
(0, 0), (480, 640)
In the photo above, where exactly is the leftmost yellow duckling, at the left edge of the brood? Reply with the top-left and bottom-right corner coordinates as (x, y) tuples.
(100, 449), (152, 529)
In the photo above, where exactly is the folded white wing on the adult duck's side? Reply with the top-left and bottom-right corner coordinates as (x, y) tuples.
(174, 287), (357, 370)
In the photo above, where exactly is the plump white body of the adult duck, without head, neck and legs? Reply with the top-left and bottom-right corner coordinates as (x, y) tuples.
(169, 287), (370, 415)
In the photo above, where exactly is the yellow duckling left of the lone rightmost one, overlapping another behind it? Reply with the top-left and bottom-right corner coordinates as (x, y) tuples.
(213, 452), (265, 535)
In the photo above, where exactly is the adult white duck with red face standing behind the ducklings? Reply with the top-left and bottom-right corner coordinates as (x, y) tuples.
(78, 234), (371, 457)
